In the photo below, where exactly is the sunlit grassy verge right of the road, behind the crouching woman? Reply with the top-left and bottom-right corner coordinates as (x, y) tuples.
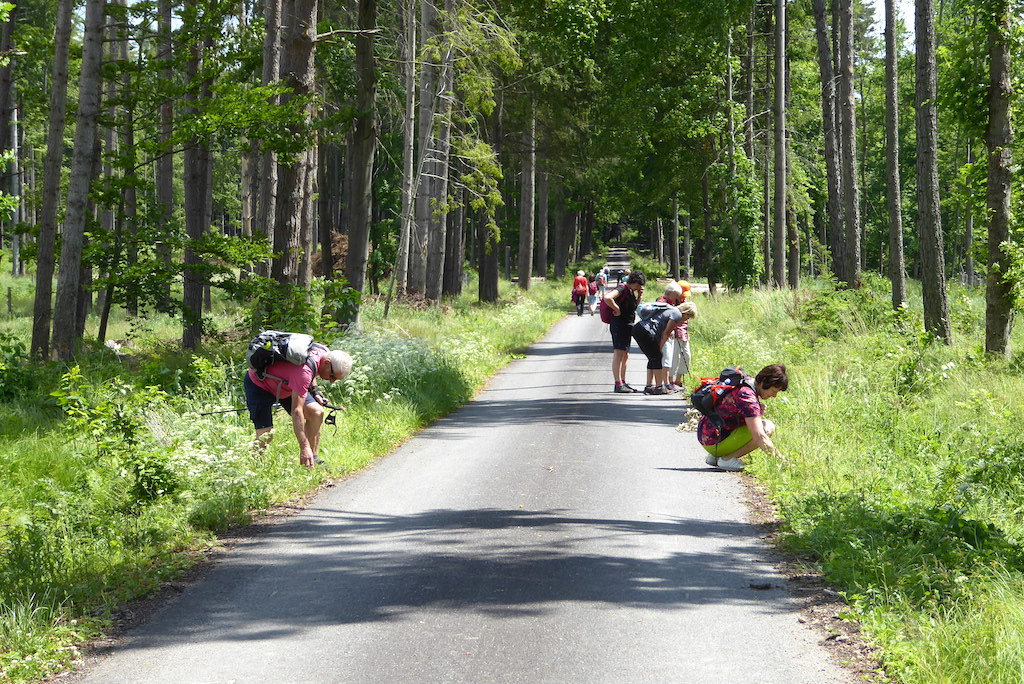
(690, 274), (1024, 684)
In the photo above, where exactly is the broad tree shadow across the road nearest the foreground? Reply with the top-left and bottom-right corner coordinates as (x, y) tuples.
(110, 508), (792, 648)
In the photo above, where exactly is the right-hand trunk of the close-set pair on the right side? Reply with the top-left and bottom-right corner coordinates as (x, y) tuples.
(838, 0), (860, 287)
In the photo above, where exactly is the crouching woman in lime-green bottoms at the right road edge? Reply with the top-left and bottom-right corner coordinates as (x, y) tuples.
(697, 364), (790, 470)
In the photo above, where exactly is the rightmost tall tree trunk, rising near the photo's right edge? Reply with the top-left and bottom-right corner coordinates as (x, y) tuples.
(985, 0), (1014, 357)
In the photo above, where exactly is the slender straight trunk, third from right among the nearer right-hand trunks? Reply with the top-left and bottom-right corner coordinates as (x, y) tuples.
(886, 0), (906, 309)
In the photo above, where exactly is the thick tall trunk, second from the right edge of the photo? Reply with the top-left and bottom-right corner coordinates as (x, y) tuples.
(914, 0), (952, 344)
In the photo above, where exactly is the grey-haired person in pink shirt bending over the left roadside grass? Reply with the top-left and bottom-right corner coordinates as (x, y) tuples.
(243, 331), (352, 468)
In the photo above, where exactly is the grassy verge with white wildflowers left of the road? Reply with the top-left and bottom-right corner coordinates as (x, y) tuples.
(0, 274), (568, 682)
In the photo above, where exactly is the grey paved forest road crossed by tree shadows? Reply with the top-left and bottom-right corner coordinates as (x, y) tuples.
(74, 315), (852, 684)
